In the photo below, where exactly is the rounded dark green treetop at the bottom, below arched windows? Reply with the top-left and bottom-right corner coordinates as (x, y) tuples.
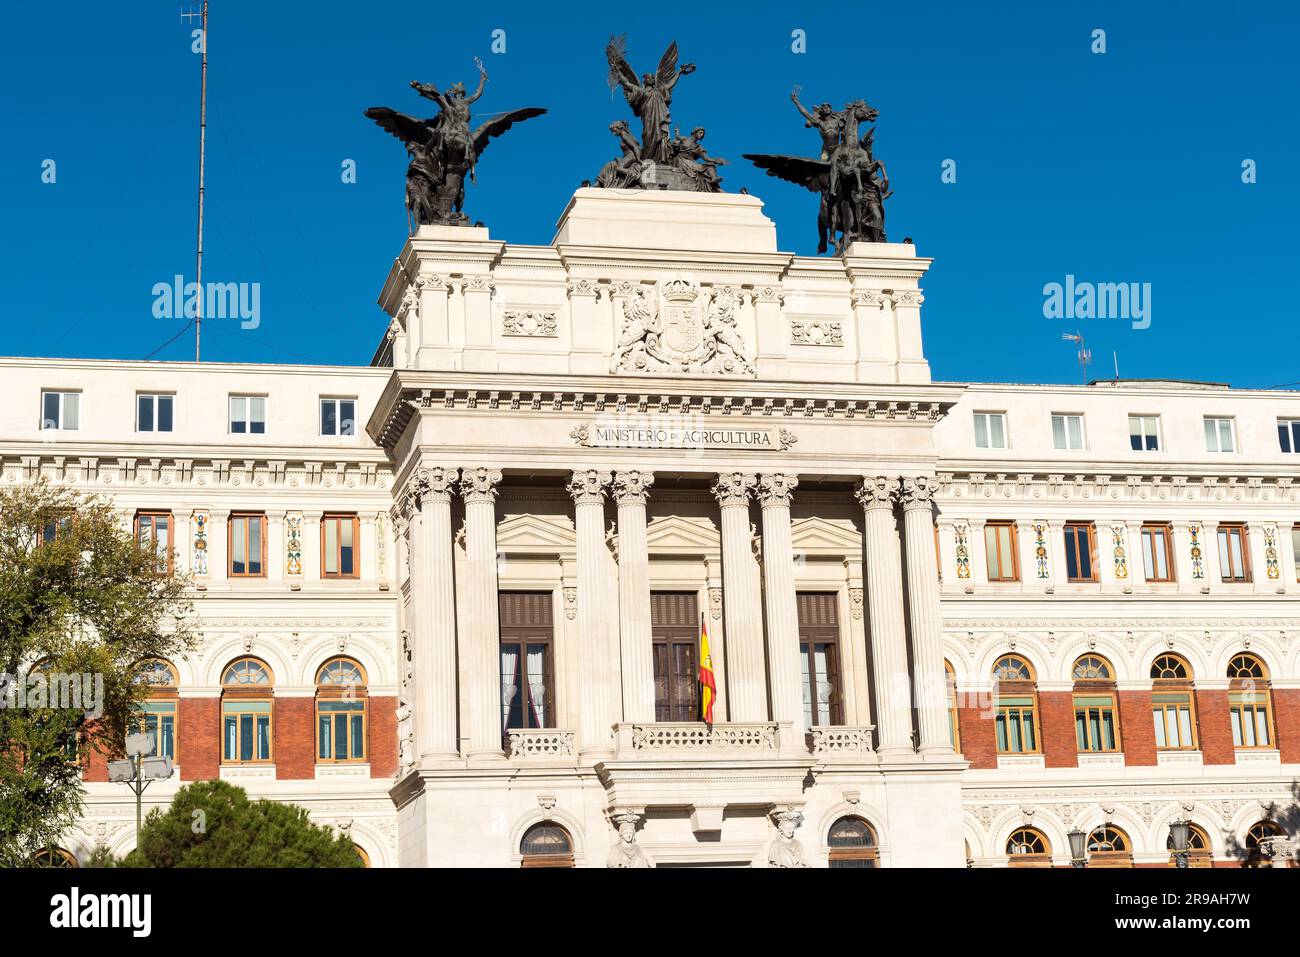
(120, 780), (361, 867)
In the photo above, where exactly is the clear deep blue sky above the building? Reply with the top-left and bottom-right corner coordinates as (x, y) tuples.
(0, 0), (1300, 387)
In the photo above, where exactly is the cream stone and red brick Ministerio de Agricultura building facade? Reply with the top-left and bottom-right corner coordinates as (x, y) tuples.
(0, 189), (1300, 867)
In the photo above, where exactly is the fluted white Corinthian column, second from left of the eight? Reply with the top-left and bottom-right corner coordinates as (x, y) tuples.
(460, 468), (502, 757)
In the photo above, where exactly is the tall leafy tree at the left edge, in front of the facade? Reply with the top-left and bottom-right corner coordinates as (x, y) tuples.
(0, 481), (194, 867)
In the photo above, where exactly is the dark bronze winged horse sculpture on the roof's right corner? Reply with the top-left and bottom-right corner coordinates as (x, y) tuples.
(744, 90), (893, 254)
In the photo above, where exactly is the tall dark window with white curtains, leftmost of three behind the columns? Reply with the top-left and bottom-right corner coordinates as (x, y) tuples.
(497, 592), (555, 731)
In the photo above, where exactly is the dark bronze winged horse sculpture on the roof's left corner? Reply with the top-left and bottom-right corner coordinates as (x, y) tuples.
(365, 57), (546, 231)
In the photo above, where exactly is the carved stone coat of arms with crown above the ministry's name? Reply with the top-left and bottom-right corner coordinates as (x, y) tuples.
(610, 280), (754, 376)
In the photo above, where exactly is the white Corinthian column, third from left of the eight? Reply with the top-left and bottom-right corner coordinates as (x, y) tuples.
(568, 468), (619, 757)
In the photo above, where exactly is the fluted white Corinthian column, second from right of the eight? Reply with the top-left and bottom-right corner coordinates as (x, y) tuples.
(857, 476), (913, 755)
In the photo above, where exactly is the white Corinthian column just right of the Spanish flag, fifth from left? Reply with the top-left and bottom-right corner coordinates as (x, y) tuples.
(714, 472), (767, 722)
